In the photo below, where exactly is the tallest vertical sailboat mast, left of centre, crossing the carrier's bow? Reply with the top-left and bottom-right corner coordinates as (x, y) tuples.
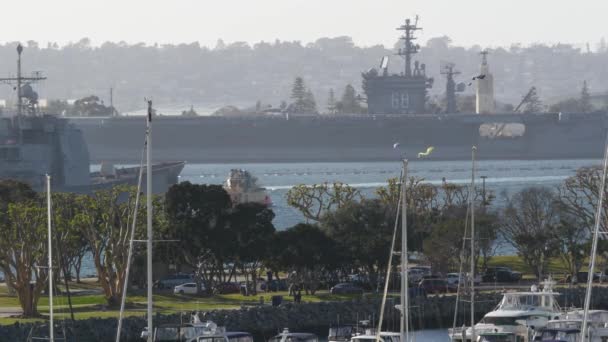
(146, 101), (154, 342)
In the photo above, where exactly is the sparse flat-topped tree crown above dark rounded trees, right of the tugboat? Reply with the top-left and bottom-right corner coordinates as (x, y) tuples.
(286, 182), (362, 222)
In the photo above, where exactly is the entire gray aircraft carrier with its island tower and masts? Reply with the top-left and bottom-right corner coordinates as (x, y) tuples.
(64, 20), (608, 163)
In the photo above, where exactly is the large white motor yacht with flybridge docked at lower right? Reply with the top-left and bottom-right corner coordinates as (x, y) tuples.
(449, 280), (561, 342)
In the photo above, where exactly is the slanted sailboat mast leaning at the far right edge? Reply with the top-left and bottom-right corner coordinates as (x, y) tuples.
(581, 137), (608, 341)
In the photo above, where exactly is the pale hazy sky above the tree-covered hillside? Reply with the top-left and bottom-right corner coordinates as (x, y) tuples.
(0, 0), (608, 48)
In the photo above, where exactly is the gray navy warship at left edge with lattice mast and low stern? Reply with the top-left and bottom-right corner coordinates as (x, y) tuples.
(0, 45), (185, 193)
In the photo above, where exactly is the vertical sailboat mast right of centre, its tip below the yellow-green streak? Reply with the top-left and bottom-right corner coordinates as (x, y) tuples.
(399, 159), (410, 342)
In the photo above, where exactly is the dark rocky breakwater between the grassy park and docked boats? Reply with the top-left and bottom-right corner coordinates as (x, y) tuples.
(0, 287), (608, 341)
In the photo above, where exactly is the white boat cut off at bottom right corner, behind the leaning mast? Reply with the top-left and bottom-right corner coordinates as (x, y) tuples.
(534, 310), (608, 342)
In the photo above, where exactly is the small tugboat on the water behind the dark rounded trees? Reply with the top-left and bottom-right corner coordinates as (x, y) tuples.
(224, 169), (272, 207)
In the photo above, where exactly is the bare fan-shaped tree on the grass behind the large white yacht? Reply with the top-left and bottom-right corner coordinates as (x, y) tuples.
(500, 187), (559, 279)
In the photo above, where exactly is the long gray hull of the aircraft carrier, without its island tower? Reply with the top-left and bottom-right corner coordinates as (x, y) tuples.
(71, 113), (608, 163)
